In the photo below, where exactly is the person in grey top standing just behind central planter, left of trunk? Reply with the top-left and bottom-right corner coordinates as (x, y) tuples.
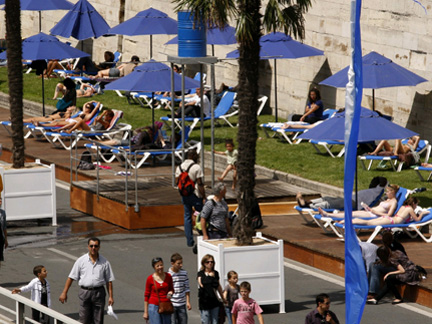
(200, 182), (231, 240)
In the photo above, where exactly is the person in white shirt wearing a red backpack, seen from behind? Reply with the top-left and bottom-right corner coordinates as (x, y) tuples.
(175, 150), (205, 247)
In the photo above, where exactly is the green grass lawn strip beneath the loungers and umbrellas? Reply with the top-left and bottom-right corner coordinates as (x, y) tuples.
(0, 68), (432, 206)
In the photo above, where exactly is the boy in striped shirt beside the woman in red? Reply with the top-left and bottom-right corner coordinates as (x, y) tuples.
(168, 253), (192, 324)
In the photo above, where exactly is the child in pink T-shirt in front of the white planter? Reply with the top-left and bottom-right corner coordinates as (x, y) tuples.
(232, 281), (264, 324)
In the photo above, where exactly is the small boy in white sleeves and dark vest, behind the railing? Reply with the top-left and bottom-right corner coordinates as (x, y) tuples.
(12, 265), (51, 324)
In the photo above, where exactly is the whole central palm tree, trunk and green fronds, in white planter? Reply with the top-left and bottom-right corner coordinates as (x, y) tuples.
(173, 0), (311, 245)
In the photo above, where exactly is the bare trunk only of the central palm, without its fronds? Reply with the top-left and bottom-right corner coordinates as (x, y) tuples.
(234, 0), (261, 245)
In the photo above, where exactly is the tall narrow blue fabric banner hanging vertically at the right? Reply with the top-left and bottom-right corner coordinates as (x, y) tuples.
(344, 0), (368, 324)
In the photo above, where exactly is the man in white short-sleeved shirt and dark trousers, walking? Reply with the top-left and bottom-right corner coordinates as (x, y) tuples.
(59, 237), (114, 324)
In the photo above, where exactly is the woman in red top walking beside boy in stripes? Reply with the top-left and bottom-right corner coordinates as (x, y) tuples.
(143, 258), (174, 324)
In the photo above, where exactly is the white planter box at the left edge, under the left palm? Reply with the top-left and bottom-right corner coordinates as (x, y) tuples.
(0, 163), (57, 226)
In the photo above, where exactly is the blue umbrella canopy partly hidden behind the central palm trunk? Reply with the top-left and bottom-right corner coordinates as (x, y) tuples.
(226, 32), (324, 60)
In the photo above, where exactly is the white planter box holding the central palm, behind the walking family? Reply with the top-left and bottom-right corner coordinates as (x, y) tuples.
(198, 232), (285, 313)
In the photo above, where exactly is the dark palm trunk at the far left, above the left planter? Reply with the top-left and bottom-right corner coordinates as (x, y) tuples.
(5, 0), (24, 168)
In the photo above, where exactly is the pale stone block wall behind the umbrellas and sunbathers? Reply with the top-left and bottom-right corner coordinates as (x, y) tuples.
(0, 0), (432, 138)
